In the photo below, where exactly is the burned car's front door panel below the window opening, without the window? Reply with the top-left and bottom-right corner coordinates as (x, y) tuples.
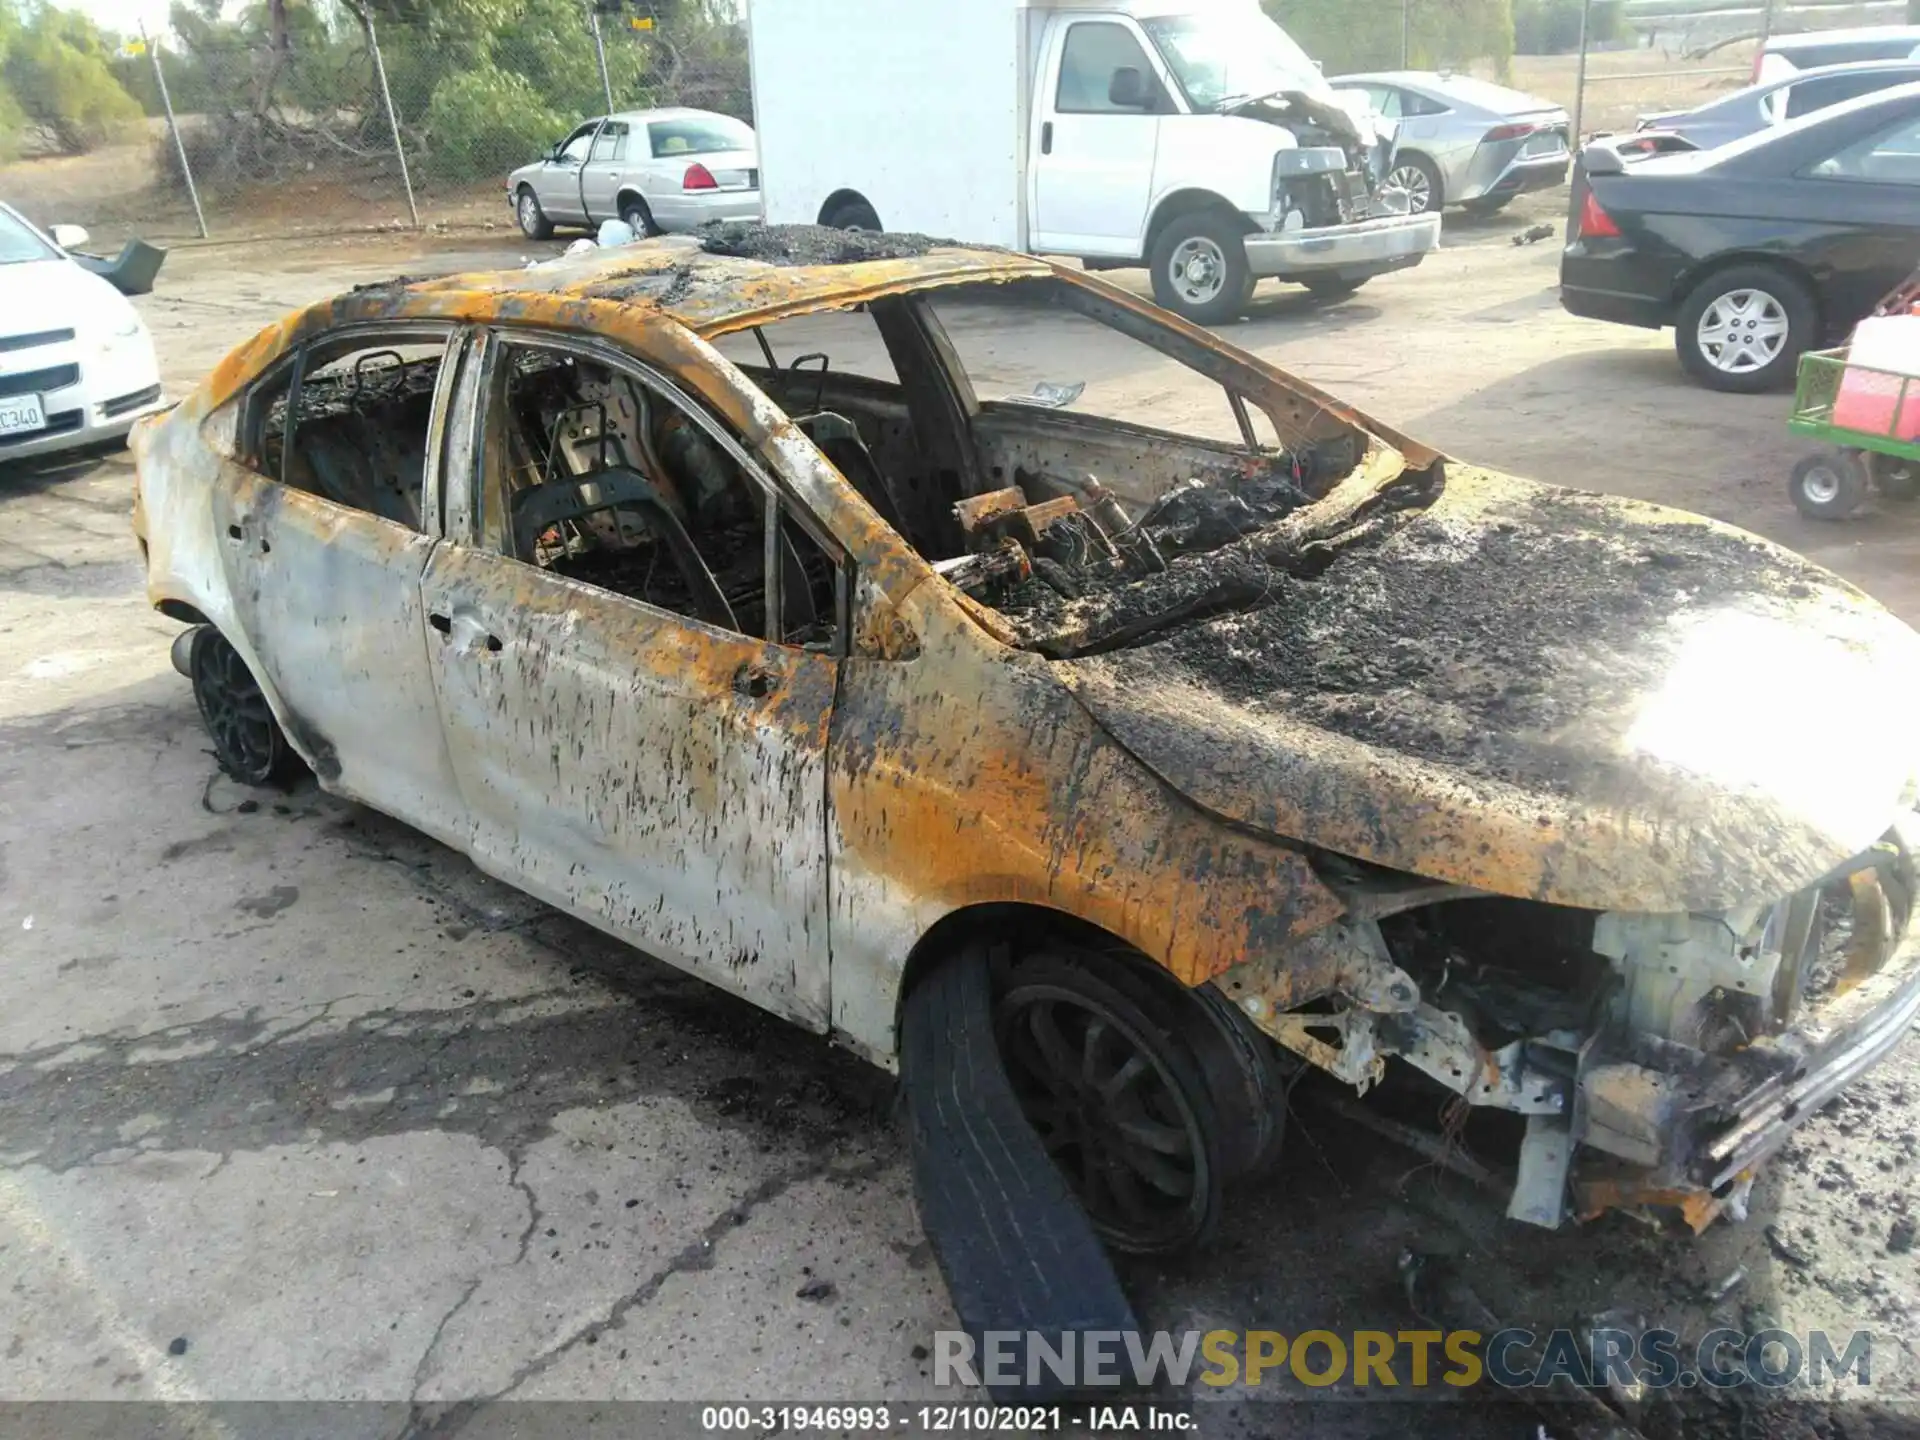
(422, 543), (835, 1029)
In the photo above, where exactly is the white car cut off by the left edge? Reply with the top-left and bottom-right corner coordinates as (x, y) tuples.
(0, 204), (167, 461)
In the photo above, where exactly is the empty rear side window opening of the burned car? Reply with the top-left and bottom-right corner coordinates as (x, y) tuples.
(259, 332), (447, 530)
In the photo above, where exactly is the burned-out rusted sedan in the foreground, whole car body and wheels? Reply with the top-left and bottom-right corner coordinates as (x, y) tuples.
(134, 230), (1920, 1273)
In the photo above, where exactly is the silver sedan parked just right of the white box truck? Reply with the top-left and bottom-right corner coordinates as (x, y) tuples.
(1332, 69), (1569, 215)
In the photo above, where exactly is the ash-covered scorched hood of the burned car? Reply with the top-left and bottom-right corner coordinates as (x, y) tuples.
(1056, 467), (1920, 912)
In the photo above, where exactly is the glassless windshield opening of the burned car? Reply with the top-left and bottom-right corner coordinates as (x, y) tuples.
(720, 280), (1361, 629)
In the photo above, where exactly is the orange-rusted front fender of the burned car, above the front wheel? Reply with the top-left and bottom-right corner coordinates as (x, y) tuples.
(828, 580), (1344, 1066)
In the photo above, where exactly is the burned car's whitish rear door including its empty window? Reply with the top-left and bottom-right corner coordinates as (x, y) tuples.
(211, 323), (465, 839)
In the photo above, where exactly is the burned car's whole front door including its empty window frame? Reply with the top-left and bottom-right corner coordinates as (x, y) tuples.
(420, 330), (845, 1029)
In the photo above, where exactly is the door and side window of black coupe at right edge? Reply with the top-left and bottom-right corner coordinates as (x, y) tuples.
(1795, 102), (1920, 324)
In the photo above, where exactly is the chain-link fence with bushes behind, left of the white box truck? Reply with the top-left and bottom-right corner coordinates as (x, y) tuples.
(8, 0), (751, 240)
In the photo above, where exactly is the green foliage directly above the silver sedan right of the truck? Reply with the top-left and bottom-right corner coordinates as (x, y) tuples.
(1263, 0), (1513, 75)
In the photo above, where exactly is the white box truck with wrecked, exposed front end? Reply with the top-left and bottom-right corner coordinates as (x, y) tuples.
(747, 0), (1440, 323)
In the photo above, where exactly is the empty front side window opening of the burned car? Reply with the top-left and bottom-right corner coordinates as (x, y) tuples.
(482, 346), (841, 651)
